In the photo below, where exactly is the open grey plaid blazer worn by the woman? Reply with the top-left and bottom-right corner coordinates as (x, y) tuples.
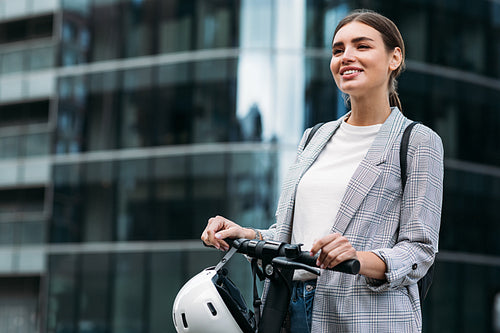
(263, 108), (444, 333)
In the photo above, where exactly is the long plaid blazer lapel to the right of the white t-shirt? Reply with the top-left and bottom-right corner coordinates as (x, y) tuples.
(332, 108), (406, 234)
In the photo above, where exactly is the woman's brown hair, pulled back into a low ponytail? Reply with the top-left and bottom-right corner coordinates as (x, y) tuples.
(333, 9), (405, 110)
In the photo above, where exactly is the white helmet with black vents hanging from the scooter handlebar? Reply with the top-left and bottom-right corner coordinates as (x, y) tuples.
(172, 267), (256, 333)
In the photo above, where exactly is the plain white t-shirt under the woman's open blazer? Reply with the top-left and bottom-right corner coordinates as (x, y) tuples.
(292, 121), (382, 281)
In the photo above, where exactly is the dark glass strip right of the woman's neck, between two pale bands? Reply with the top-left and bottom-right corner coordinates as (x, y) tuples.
(399, 70), (500, 165)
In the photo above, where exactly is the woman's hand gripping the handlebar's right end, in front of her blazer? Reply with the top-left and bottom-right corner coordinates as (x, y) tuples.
(311, 233), (358, 268)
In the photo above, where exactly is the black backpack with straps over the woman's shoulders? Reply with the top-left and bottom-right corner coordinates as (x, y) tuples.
(304, 121), (434, 303)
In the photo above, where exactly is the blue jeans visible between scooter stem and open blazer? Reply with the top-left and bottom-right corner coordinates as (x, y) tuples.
(288, 280), (316, 333)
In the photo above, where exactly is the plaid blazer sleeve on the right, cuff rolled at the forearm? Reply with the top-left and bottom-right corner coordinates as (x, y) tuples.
(366, 125), (444, 291)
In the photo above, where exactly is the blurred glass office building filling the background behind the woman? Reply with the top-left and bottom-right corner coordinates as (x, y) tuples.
(0, 0), (500, 333)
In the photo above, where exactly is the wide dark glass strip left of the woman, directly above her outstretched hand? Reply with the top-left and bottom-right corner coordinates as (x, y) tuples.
(50, 151), (279, 243)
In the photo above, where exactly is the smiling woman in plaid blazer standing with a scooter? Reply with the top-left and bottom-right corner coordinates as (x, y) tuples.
(202, 11), (443, 332)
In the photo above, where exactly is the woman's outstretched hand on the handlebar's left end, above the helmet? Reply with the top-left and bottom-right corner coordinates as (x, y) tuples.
(201, 216), (255, 251)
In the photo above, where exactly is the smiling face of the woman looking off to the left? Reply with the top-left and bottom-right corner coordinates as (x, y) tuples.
(330, 21), (402, 98)
